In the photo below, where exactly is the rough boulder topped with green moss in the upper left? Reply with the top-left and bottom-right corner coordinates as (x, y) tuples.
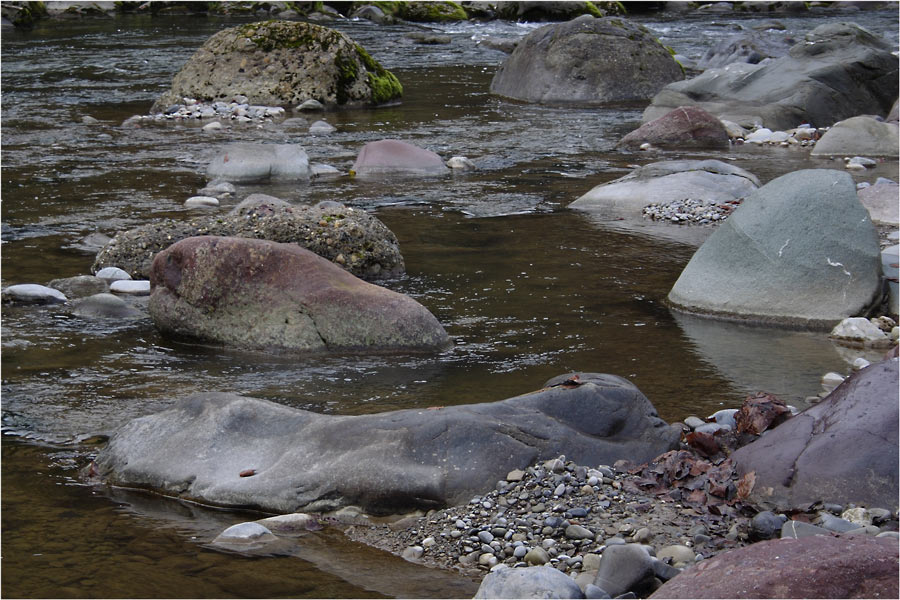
(150, 21), (403, 113)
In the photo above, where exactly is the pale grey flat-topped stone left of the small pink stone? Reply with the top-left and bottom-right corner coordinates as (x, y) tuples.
(206, 144), (310, 183)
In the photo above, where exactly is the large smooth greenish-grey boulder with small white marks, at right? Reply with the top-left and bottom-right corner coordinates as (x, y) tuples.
(669, 169), (881, 329)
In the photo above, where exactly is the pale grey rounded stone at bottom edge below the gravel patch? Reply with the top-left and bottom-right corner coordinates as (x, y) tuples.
(474, 566), (584, 598)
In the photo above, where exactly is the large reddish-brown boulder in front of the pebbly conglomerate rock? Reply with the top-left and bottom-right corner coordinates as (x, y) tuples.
(149, 236), (449, 351)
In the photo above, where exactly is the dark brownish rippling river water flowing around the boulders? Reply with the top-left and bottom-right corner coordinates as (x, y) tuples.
(0, 11), (897, 597)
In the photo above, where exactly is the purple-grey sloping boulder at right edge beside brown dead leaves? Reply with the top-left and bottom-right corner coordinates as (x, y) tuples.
(731, 359), (898, 511)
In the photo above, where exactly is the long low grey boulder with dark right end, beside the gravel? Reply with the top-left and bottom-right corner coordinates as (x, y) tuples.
(97, 373), (680, 514)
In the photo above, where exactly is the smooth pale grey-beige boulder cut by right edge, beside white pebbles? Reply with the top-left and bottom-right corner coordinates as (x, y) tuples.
(811, 116), (900, 156)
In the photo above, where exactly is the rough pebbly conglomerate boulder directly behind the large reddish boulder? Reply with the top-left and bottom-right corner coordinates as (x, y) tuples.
(91, 194), (404, 280)
